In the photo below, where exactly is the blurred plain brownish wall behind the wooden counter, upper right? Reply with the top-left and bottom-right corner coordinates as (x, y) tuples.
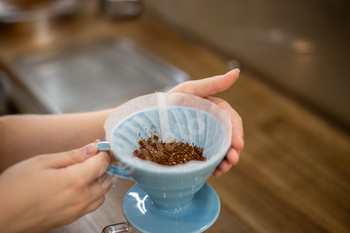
(145, 0), (350, 130)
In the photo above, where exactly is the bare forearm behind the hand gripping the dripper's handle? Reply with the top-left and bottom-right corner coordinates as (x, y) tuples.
(0, 109), (113, 172)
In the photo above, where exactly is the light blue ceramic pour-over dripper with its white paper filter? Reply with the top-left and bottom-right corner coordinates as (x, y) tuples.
(99, 93), (231, 232)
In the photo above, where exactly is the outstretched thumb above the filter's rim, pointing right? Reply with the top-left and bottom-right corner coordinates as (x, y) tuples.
(169, 69), (239, 97)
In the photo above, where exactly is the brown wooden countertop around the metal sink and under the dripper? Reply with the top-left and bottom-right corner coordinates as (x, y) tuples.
(0, 0), (350, 233)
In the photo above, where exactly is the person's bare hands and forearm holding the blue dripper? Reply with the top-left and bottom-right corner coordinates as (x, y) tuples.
(0, 70), (244, 232)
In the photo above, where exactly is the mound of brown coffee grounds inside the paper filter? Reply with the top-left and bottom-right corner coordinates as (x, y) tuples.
(133, 135), (207, 166)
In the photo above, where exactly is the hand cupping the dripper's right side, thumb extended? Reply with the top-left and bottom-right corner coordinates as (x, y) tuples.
(169, 69), (244, 176)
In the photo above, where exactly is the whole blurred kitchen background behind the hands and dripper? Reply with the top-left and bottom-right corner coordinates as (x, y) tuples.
(0, 0), (350, 233)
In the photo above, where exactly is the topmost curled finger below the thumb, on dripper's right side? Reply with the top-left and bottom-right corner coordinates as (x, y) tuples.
(207, 97), (244, 151)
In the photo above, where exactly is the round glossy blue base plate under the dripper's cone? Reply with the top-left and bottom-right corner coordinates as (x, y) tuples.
(123, 183), (220, 233)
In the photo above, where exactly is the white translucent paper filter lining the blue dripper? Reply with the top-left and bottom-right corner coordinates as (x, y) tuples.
(105, 93), (232, 170)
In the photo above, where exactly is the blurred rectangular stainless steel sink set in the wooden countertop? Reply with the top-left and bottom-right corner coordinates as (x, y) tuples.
(13, 38), (189, 113)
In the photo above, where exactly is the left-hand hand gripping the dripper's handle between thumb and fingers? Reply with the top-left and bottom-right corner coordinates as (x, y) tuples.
(0, 143), (112, 232)
